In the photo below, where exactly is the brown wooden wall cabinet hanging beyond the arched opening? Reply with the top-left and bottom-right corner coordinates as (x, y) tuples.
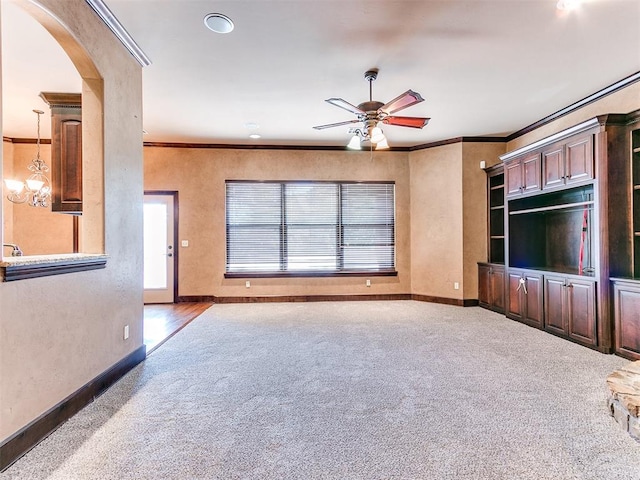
(40, 92), (82, 215)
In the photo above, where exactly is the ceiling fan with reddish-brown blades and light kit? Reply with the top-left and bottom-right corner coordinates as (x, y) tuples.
(313, 69), (430, 150)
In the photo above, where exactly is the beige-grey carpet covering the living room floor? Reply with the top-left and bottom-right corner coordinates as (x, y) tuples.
(0, 301), (640, 480)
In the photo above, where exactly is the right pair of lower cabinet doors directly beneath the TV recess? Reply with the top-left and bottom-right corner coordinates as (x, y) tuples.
(544, 274), (596, 346)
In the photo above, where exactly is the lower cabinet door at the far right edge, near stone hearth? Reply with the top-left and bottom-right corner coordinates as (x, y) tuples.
(613, 283), (640, 360)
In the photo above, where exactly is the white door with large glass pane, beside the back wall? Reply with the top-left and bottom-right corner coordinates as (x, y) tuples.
(144, 194), (175, 303)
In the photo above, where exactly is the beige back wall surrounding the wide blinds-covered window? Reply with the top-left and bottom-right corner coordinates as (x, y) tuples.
(144, 147), (411, 297)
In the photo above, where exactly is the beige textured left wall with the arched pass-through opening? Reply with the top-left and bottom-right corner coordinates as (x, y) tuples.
(0, 0), (142, 441)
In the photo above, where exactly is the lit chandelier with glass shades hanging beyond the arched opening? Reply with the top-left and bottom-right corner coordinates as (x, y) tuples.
(4, 110), (51, 207)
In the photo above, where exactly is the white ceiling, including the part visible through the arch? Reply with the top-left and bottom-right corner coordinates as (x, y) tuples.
(2, 0), (640, 146)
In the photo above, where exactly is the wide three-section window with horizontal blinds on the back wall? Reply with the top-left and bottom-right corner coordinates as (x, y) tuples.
(226, 181), (395, 277)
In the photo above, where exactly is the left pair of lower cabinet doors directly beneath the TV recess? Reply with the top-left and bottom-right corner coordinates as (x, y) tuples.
(506, 269), (544, 328)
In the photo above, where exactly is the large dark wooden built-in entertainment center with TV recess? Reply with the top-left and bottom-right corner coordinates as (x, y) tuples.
(500, 112), (640, 356)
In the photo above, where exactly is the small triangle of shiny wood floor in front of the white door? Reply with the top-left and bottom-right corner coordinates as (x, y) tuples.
(144, 302), (213, 355)
